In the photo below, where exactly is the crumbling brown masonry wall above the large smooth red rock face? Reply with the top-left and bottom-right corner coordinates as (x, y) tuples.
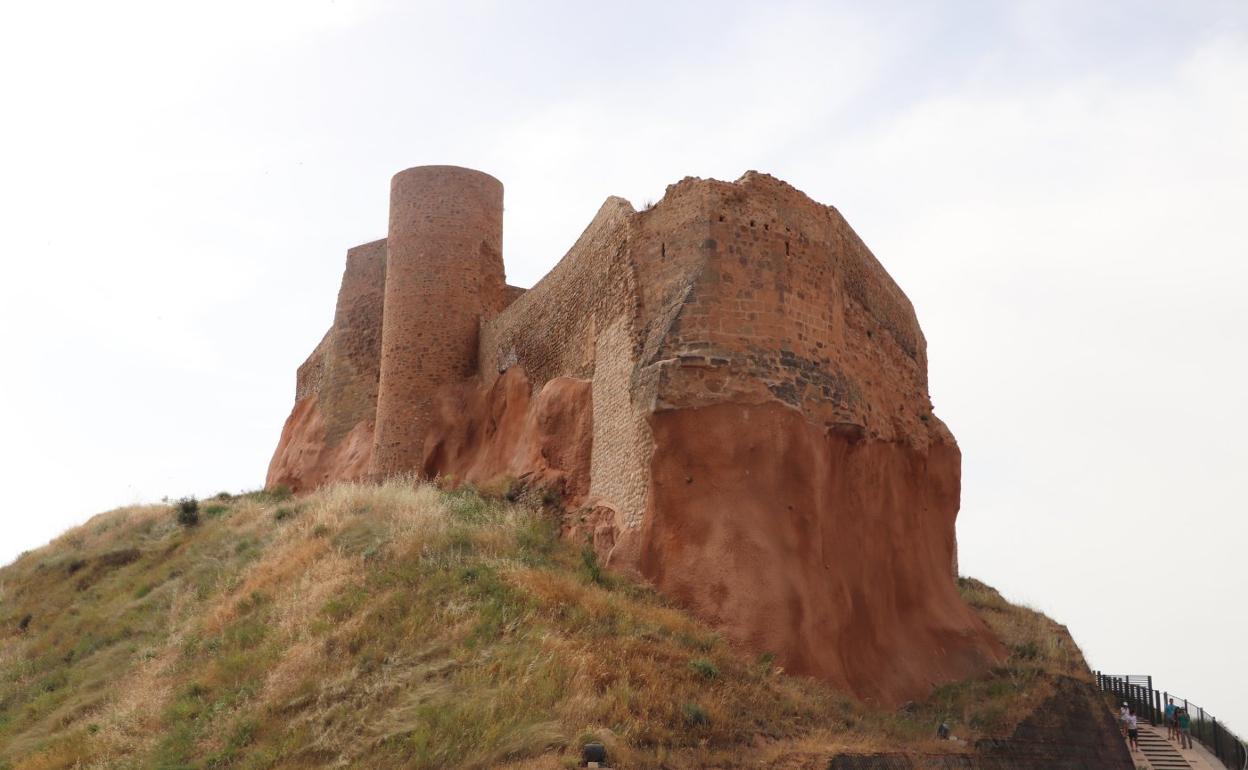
(653, 173), (951, 444)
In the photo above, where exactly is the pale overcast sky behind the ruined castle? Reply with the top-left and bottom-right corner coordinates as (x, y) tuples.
(0, 0), (1248, 738)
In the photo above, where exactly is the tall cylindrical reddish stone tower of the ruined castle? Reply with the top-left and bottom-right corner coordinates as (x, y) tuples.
(372, 166), (505, 478)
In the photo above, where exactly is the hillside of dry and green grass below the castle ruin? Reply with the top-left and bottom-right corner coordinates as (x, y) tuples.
(0, 482), (1085, 770)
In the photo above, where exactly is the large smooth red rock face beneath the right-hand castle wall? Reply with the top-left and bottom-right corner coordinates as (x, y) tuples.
(640, 403), (996, 703)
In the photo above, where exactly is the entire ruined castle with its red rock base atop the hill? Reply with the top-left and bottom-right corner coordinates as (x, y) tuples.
(267, 166), (1002, 703)
